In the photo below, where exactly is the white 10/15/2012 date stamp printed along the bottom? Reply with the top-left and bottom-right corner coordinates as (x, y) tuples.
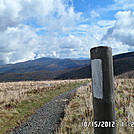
(82, 121), (134, 127)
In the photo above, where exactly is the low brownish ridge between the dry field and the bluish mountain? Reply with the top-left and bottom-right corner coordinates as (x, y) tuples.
(0, 66), (87, 82)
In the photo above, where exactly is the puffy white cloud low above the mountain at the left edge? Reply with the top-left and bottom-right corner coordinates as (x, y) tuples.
(0, 25), (38, 64)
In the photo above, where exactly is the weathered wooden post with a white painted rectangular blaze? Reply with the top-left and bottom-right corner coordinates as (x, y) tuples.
(90, 46), (116, 134)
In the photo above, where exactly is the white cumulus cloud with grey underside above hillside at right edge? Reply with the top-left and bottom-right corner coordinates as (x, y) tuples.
(102, 11), (134, 52)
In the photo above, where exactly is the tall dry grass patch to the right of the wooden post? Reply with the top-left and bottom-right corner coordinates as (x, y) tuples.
(115, 79), (134, 134)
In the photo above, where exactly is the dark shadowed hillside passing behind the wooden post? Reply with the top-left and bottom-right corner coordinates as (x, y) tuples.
(56, 52), (134, 79)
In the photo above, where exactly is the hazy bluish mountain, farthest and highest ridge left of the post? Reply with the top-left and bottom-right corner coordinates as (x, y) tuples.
(0, 57), (90, 73)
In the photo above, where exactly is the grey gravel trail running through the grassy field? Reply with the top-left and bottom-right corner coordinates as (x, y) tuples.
(10, 88), (78, 134)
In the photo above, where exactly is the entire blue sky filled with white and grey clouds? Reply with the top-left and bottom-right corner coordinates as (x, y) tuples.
(0, 0), (134, 64)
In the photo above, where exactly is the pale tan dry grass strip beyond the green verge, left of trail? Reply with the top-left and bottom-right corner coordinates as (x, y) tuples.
(0, 79), (87, 105)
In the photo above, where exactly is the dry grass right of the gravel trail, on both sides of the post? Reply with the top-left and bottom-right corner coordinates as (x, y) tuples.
(57, 79), (134, 134)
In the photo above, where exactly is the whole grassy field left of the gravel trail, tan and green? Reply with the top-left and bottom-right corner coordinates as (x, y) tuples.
(0, 79), (87, 134)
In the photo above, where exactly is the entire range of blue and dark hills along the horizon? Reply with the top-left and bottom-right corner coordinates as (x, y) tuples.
(0, 52), (134, 82)
